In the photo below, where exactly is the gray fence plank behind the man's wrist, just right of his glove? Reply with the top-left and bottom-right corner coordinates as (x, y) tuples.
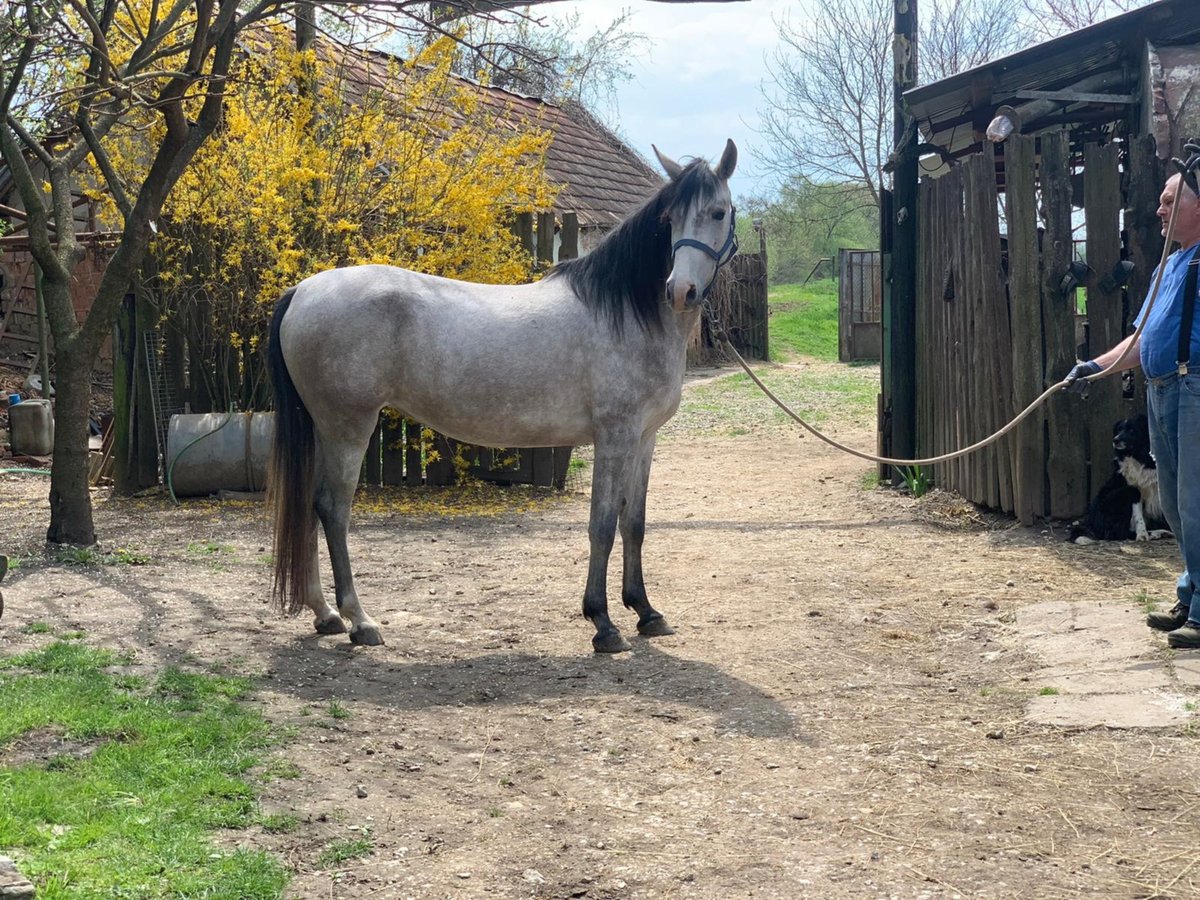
(1084, 143), (1124, 504)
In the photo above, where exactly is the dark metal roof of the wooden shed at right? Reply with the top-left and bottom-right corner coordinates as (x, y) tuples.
(904, 0), (1200, 164)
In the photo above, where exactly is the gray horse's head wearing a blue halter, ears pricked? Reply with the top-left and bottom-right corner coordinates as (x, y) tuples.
(654, 140), (738, 312)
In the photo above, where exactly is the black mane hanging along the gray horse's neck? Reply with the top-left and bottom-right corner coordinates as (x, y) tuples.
(547, 160), (719, 334)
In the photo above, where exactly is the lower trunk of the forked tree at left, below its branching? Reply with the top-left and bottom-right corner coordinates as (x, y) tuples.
(46, 344), (96, 546)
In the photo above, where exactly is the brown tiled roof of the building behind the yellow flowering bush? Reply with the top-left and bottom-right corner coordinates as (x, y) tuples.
(304, 34), (664, 229)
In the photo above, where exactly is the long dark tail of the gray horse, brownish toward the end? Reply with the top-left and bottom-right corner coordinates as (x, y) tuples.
(268, 288), (317, 614)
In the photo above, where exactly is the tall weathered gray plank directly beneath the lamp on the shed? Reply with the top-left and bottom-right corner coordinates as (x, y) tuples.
(1004, 134), (1046, 526)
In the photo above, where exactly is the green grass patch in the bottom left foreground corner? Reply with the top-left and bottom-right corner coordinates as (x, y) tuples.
(0, 642), (294, 900)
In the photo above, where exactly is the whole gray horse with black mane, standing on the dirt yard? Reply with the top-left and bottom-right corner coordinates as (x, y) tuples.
(270, 140), (737, 653)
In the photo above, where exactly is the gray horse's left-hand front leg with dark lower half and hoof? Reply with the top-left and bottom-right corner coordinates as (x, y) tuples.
(583, 437), (636, 653)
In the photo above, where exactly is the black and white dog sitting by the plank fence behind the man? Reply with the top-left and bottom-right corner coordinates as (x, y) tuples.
(1069, 415), (1171, 544)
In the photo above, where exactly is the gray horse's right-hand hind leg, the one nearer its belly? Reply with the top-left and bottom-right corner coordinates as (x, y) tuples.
(316, 428), (383, 647)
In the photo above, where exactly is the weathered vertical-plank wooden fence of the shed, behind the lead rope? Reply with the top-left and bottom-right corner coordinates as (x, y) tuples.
(917, 133), (1163, 523)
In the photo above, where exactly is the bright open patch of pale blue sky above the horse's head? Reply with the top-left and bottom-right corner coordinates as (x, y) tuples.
(544, 0), (800, 197)
